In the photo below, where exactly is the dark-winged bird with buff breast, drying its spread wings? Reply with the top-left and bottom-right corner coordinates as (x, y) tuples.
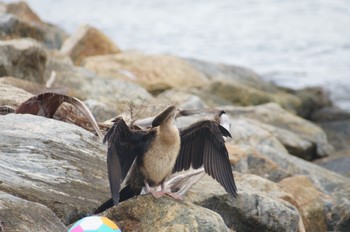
(95, 105), (237, 214)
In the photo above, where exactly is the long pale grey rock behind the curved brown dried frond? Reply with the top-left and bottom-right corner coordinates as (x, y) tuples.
(45, 54), (154, 111)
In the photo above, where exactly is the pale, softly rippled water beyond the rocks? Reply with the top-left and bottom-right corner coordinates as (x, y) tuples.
(4, 0), (350, 111)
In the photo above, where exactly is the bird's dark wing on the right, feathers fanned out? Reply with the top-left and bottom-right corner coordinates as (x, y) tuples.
(173, 120), (237, 197)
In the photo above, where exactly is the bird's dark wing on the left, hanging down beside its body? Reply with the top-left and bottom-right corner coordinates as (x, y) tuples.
(103, 118), (153, 205)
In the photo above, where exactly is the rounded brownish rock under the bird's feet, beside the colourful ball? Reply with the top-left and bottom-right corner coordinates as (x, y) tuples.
(103, 194), (228, 232)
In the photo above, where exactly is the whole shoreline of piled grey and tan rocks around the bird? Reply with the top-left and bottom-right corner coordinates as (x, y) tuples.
(0, 2), (350, 231)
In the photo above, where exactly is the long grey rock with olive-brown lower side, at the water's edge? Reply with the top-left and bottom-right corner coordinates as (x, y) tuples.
(188, 59), (301, 112)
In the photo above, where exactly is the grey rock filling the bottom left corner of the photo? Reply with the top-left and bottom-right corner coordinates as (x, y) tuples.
(0, 191), (67, 232)
